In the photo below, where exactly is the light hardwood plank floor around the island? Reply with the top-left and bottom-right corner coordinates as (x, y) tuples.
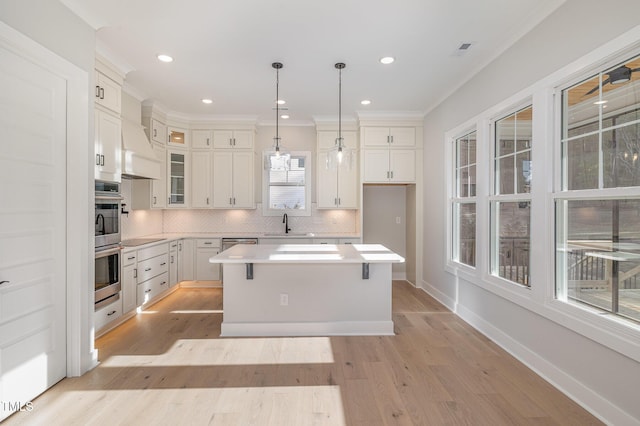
(6, 281), (600, 426)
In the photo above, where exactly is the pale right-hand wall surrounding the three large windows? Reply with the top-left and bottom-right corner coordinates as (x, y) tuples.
(422, 0), (640, 424)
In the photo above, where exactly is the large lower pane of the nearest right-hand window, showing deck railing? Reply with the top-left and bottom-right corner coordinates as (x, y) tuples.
(558, 200), (640, 321)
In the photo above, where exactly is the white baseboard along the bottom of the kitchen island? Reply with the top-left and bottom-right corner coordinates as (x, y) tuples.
(220, 321), (394, 337)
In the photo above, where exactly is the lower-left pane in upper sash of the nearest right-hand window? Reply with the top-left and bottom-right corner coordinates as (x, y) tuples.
(564, 134), (599, 190)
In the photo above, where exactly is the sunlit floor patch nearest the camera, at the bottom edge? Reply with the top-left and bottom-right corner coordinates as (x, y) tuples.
(27, 386), (346, 426)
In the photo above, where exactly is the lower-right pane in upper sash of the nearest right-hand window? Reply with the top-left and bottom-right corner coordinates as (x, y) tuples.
(602, 124), (640, 188)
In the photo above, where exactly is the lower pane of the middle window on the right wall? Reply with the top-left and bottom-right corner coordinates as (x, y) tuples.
(493, 201), (531, 286)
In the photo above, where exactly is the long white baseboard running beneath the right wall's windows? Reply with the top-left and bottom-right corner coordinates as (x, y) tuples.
(458, 302), (638, 425)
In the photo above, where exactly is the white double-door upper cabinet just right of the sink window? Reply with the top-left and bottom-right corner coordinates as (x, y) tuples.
(317, 151), (359, 209)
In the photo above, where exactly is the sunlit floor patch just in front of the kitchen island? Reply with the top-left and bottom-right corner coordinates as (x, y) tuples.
(101, 337), (334, 367)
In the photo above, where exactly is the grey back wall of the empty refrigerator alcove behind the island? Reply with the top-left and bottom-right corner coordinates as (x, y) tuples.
(362, 185), (407, 279)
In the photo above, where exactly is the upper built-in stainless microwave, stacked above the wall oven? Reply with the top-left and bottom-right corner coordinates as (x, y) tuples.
(94, 181), (122, 250)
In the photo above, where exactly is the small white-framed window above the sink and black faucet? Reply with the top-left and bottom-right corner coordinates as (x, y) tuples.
(262, 152), (311, 216)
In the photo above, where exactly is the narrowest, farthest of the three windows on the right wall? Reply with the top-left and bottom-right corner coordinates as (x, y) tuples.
(451, 131), (476, 266)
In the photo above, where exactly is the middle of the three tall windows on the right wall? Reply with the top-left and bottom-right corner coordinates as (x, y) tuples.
(490, 106), (533, 286)
